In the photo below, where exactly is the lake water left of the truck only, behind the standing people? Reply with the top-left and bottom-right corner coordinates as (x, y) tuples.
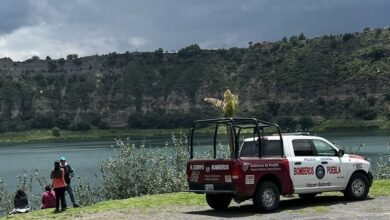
(0, 136), (170, 189)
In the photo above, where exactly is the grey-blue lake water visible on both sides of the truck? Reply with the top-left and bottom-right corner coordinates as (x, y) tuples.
(0, 132), (390, 190)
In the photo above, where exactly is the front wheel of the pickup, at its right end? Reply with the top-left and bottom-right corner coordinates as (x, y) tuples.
(344, 173), (369, 200)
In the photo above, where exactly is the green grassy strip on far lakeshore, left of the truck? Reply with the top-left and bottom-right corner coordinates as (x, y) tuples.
(0, 129), (187, 144)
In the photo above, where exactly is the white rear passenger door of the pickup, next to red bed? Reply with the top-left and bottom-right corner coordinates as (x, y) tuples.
(289, 139), (322, 193)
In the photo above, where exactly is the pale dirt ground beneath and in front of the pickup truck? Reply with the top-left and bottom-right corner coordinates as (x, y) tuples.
(75, 196), (390, 220)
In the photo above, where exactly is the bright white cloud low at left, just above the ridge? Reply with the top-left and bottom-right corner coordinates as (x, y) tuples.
(0, 24), (131, 61)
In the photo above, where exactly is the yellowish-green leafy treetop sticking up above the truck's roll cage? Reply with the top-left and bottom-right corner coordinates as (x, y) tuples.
(204, 89), (238, 117)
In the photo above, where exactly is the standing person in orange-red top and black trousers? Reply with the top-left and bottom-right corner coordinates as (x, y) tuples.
(50, 161), (66, 212)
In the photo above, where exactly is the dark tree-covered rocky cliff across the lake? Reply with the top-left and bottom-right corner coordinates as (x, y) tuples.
(0, 29), (390, 131)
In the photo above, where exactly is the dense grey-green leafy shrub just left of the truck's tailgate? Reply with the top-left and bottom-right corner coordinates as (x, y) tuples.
(100, 136), (188, 199)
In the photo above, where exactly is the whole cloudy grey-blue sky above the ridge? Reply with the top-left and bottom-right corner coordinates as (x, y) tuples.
(0, 0), (390, 61)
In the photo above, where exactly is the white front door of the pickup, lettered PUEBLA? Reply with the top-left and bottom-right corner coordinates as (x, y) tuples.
(312, 139), (347, 190)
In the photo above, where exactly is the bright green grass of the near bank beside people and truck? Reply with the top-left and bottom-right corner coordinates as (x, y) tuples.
(0, 180), (390, 219)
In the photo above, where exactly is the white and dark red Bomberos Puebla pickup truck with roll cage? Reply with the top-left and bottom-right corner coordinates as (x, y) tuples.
(186, 118), (373, 211)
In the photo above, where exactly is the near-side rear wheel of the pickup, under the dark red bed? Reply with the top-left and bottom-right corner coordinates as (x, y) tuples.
(253, 181), (280, 212)
